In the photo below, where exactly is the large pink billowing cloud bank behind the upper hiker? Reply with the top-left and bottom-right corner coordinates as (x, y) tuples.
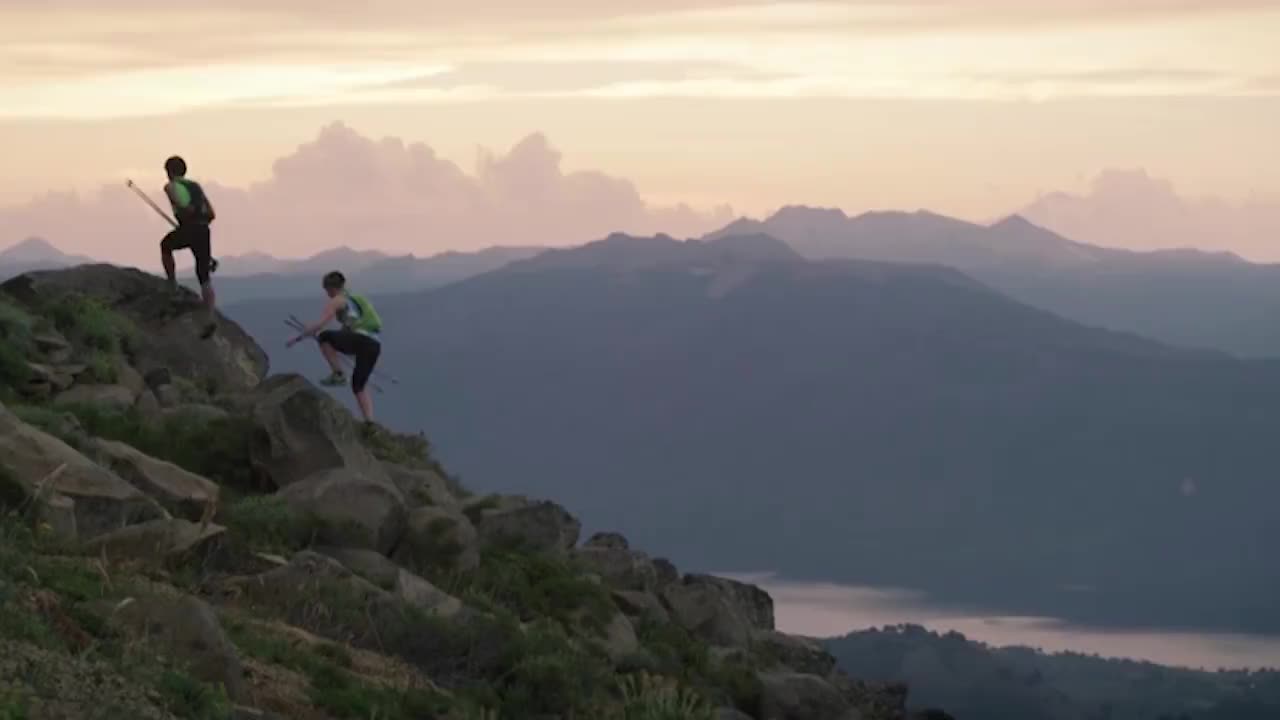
(0, 123), (732, 265)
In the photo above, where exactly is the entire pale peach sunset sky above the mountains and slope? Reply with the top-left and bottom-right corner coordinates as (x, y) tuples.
(0, 0), (1280, 258)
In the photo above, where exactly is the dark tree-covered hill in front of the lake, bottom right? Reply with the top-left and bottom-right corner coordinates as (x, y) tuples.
(824, 626), (1280, 720)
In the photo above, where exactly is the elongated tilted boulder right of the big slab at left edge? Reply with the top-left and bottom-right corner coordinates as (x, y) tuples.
(91, 438), (219, 520)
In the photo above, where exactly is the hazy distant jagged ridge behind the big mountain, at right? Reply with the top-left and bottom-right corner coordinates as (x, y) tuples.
(708, 206), (1280, 356)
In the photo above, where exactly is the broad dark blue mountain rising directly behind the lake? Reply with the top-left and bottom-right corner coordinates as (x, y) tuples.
(228, 236), (1280, 629)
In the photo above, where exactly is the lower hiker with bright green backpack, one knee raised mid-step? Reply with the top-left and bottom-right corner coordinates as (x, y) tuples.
(288, 270), (383, 423)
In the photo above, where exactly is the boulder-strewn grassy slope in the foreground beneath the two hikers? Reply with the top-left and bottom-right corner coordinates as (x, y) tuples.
(0, 265), (934, 720)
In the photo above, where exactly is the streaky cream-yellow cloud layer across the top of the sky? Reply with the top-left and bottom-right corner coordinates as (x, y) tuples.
(0, 0), (1280, 118)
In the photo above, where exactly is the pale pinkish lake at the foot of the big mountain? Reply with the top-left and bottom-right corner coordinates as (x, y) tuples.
(722, 573), (1280, 670)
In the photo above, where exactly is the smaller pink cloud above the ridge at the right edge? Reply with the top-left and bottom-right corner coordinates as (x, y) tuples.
(1020, 169), (1280, 261)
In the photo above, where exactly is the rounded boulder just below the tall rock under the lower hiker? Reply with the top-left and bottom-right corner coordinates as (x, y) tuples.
(276, 468), (407, 555)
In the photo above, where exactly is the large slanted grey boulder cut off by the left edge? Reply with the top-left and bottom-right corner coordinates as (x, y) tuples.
(0, 406), (166, 539)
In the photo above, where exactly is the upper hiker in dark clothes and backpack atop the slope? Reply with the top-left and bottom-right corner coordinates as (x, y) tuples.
(160, 156), (218, 338)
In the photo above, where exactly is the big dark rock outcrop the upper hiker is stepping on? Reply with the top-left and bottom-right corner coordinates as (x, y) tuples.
(0, 264), (268, 391)
